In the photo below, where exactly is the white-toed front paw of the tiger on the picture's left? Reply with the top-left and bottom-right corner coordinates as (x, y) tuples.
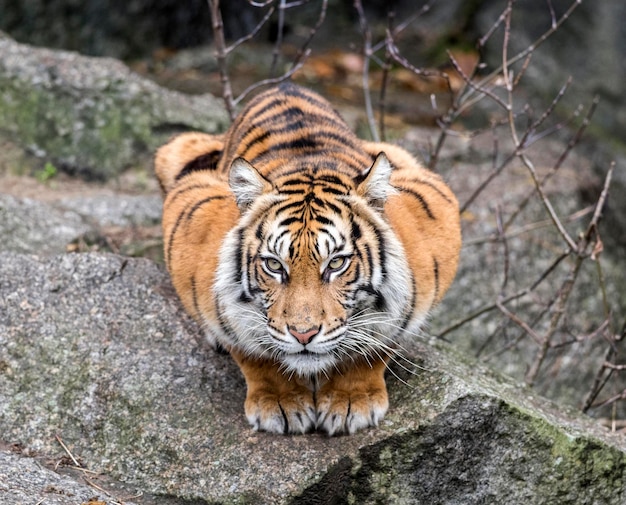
(245, 390), (316, 435)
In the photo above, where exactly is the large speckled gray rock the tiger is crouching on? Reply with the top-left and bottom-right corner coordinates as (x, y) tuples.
(0, 253), (626, 505)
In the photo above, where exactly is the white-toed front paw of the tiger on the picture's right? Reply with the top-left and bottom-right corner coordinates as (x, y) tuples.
(317, 387), (389, 436)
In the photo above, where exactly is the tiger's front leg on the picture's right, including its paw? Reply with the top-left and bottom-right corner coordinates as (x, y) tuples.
(315, 360), (389, 435)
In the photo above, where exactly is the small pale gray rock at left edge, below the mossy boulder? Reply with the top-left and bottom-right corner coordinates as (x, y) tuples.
(0, 193), (91, 255)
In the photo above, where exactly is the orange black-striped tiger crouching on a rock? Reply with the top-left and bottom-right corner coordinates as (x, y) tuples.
(154, 82), (461, 436)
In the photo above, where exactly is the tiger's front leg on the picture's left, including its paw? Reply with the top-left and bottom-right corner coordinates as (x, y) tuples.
(231, 350), (316, 434)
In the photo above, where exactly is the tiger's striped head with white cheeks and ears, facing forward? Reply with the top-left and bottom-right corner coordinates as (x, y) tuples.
(214, 153), (415, 375)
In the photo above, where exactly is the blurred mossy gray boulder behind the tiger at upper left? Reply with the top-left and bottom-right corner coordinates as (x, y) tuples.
(0, 33), (228, 179)
